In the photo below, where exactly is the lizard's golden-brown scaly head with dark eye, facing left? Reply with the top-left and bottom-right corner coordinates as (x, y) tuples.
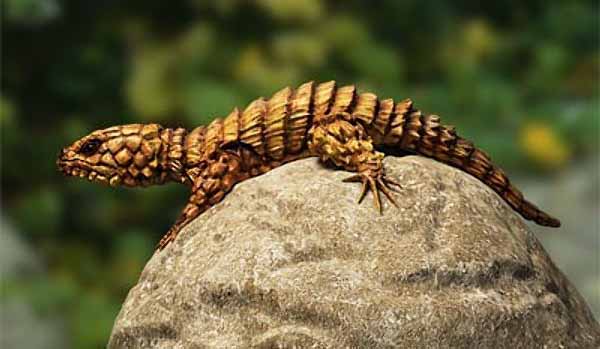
(56, 124), (165, 186)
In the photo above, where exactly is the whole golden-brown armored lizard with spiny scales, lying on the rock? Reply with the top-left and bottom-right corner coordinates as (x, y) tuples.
(57, 81), (560, 249)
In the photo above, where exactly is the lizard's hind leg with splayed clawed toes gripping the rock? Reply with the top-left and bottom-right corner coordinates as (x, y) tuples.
(308, 113), (400, 213)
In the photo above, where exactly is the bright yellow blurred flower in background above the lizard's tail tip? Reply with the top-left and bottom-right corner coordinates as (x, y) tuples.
(520, 122), (571, 168)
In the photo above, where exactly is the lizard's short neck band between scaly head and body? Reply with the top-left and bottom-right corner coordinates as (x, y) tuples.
(158, 128), (187, 183)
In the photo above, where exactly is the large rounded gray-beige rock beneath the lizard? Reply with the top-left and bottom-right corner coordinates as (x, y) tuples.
(108, 156), (600, 348)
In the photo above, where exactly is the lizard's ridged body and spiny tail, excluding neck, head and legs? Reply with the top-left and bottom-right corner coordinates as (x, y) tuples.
(187, 81), (560, 227)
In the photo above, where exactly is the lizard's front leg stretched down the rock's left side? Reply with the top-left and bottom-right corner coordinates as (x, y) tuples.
(157, 151), (245, 250)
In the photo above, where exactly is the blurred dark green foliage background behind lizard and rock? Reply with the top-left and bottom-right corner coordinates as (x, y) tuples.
(0, 0), (600, 348)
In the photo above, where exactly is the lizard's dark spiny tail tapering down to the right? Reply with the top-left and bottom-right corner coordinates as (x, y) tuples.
(383, 100), (560, 227)
